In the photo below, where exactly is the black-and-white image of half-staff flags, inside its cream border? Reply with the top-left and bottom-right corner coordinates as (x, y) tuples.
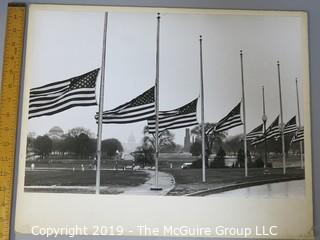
(20, 6), (311, 198)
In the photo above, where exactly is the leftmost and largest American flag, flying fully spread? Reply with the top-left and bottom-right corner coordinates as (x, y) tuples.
(29, 68), (99, 119)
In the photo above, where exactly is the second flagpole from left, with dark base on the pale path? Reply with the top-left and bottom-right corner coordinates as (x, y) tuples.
(151, 13), (162, 190)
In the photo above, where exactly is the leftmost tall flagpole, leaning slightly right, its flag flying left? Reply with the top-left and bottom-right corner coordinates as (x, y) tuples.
(96, 12), (108, 194)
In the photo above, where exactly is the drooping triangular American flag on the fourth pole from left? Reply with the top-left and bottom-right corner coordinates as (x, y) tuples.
(206, 102), (242, 134)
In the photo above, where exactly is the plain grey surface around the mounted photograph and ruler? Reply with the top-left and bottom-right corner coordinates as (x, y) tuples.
(0, 0), (320, 240)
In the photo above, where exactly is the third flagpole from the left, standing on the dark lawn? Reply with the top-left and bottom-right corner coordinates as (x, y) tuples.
(200, 35), (206, 182)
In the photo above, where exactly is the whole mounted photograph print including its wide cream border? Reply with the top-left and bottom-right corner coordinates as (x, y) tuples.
(15, 4), (312, 238)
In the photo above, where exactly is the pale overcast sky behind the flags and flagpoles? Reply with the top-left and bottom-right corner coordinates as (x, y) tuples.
(26, 8), (304, 144)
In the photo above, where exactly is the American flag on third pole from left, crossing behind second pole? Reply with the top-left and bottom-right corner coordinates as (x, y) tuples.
(148, 99), (198, 133)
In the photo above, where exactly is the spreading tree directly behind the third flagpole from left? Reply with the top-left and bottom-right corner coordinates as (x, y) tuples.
(191, 123), (227, 167)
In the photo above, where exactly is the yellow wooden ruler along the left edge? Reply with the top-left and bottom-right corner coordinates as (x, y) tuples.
(0, 4), (26, 240)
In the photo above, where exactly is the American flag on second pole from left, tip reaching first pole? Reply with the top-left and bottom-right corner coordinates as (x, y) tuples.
(95, 87), (155, 124)
